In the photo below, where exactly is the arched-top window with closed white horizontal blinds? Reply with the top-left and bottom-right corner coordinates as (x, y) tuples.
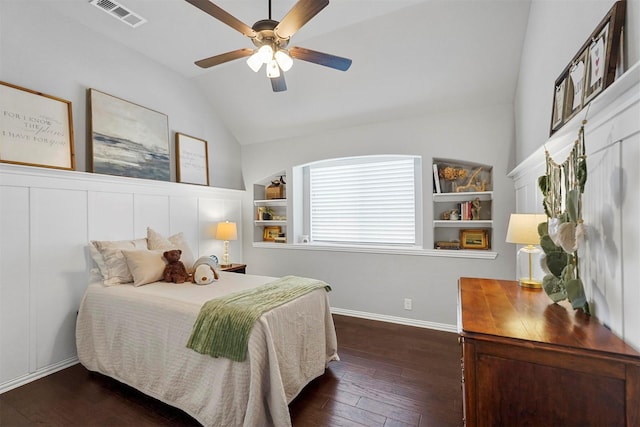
(304, 156), (422, 247)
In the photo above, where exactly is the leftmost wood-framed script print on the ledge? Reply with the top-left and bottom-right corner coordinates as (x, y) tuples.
(0, 81), (75, 170)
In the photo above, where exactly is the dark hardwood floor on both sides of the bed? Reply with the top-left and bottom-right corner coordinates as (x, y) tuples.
(0, 315), (462, 427)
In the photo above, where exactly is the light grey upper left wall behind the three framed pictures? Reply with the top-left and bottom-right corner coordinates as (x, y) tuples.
(0, 1), (243, 189)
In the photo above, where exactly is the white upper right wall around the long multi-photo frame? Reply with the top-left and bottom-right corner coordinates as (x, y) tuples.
(515, 0), (640, 163)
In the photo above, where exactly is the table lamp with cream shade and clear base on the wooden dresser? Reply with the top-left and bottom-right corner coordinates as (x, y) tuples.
(506, 214), (547, 289)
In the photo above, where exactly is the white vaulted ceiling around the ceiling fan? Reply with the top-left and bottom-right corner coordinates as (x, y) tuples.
(45, 0), (529, 144)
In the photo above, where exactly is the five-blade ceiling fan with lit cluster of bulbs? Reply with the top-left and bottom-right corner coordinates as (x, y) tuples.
(186, 0), (351, 92)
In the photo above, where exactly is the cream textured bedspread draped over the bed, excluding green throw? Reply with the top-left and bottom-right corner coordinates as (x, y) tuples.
(76, 272), (338, 426)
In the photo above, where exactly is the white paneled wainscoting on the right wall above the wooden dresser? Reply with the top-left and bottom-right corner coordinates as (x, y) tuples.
(510, 64), (640, 350)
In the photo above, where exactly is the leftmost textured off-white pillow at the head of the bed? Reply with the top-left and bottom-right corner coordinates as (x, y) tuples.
(89, 239), (147, 286)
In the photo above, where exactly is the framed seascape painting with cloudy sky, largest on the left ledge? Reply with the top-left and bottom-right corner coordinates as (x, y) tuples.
(89, 89), (171, 181)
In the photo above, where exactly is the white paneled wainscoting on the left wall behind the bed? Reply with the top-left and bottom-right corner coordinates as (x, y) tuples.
(0, 164), (244, 393)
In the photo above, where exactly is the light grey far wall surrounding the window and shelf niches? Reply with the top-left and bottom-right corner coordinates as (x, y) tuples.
(242, 105), (515, 330)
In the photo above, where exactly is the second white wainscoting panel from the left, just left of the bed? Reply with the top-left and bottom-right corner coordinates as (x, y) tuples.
(30, 188), (88, 370)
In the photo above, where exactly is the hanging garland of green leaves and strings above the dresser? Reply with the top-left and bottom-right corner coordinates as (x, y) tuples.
(538, 120), (589, 314)
